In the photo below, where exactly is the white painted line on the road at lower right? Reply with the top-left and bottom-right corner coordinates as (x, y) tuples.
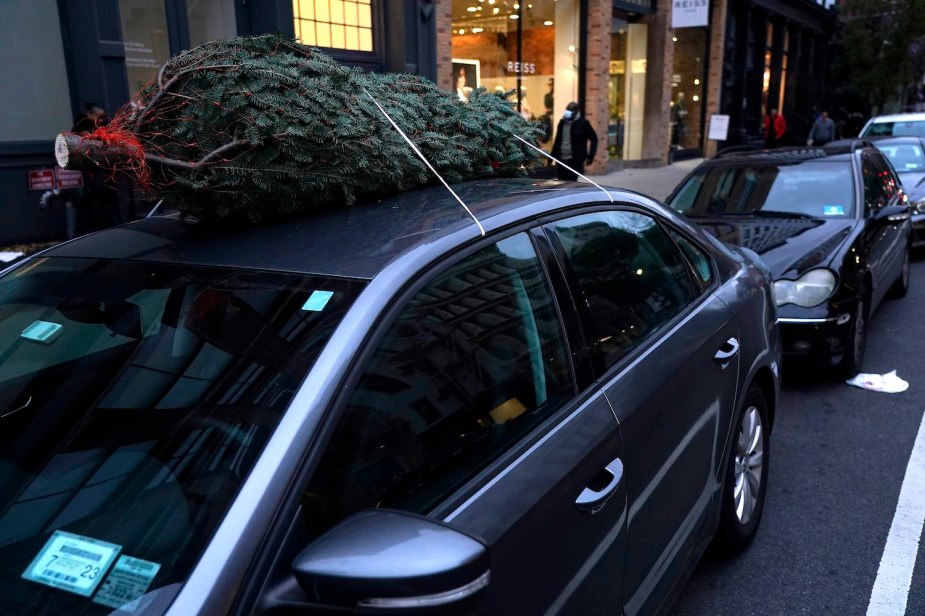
(867, 416), (925, 616)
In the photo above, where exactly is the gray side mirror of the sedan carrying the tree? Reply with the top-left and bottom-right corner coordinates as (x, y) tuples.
(292, 509), (489, 614)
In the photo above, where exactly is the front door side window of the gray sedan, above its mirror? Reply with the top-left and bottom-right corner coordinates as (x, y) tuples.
(306, 233), (572, 532)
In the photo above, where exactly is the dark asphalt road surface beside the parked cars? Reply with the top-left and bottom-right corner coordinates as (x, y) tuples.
(672, 255), (925, 616)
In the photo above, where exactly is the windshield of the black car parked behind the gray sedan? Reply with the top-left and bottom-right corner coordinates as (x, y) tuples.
(669, 161), (854, 218)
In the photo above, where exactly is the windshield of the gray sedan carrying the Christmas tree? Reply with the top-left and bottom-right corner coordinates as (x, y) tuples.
(0, 258), (364, 614)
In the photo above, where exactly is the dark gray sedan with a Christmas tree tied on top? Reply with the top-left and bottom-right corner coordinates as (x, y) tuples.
(0, 180), (780, 616)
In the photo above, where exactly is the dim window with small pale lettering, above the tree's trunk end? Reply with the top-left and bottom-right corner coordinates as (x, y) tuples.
(119, 0), (170, 92)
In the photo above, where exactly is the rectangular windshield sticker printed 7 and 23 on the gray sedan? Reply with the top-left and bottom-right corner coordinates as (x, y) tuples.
(22, 530), (122, 597)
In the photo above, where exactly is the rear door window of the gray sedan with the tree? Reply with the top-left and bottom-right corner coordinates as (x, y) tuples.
(548, 212), (695, 367)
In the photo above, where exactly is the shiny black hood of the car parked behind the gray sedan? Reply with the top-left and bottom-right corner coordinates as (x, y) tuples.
(692, 216), (857, 278)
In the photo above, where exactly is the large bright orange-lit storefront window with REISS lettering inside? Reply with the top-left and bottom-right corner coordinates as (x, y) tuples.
(452, 0), (580, 147)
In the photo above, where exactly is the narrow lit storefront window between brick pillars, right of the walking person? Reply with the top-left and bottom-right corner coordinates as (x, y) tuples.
(607, 19), (648, 160)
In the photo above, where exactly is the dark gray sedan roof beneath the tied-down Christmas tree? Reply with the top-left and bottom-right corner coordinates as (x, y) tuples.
(42, 178), (631, 279)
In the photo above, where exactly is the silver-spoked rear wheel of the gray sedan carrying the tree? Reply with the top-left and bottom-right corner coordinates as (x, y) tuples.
(714, 385), (771, 554)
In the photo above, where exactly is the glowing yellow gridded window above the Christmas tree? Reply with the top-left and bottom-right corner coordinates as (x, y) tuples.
(292, 0), (373, 51)
